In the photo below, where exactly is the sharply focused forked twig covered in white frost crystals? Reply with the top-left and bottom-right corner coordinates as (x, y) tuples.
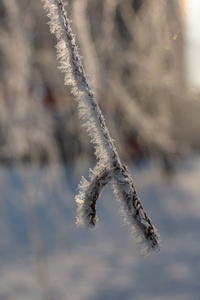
(42, 0), (160, 253)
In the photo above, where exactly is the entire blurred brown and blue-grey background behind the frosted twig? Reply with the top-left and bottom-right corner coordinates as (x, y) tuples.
(0, 0), (200, 300)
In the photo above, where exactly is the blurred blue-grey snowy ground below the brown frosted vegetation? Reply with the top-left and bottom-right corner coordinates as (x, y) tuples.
(0, 156), (200, 300)
